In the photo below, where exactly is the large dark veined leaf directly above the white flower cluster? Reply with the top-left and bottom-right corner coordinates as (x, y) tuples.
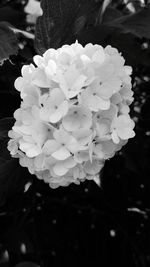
(35, 0), (101, 54)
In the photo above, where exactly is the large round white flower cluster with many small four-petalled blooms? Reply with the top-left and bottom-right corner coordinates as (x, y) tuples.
(8, 42), (135, 188)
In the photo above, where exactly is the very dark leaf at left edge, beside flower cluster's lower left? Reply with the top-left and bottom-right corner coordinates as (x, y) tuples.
(0, 118), (29, 205)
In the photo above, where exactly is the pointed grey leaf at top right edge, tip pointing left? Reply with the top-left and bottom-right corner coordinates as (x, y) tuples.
(106, 5), (150, 38)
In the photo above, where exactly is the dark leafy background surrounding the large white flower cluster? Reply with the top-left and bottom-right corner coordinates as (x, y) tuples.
(0, 0), (150, 267)
